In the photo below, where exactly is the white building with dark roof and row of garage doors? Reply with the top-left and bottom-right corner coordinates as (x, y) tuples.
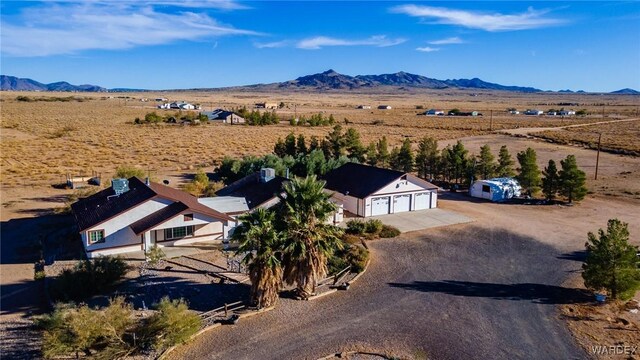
(323, 163), (438, 217)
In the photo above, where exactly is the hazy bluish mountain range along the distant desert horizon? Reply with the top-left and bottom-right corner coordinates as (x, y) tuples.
(0, 70), (640, 95)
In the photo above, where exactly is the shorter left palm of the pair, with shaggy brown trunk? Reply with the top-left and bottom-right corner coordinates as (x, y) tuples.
(231, 208), (282, 308)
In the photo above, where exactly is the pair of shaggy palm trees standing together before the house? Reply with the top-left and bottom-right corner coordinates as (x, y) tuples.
(232, 175), (344, 308)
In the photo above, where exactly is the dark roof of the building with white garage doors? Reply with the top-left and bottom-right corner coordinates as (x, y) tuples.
(323, 163), (437, 199)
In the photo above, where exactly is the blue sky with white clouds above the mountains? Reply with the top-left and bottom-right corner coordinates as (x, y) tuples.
(0, 0), (640, 92)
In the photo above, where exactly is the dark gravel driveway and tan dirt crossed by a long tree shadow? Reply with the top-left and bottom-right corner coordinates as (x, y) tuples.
(171, 196), (640, 359)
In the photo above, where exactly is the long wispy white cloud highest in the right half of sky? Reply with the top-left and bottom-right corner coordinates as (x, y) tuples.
(391, 5), (566, 31)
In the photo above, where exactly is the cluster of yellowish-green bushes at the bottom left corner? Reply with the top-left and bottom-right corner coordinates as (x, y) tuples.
(36, 297), (201, 359)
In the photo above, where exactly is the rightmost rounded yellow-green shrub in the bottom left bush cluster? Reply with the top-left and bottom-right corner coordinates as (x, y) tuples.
(145, 297), (202, 350)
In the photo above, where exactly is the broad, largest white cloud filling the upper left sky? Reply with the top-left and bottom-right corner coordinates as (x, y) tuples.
(1, 1), (258, 57)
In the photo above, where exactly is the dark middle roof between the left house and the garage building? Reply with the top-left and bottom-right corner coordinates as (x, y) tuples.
(216, 172), (288, 209)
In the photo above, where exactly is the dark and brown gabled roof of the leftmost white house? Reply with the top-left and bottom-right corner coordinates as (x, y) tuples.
(71, 177), (233, 231)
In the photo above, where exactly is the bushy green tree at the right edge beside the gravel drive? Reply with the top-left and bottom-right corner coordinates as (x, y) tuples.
(582, 219), (640, 299)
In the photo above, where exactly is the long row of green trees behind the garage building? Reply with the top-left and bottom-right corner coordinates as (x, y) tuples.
(218, 124), (587, 202)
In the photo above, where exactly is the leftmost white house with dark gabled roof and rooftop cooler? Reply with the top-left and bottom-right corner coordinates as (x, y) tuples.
(71, 177), (235, 258)
